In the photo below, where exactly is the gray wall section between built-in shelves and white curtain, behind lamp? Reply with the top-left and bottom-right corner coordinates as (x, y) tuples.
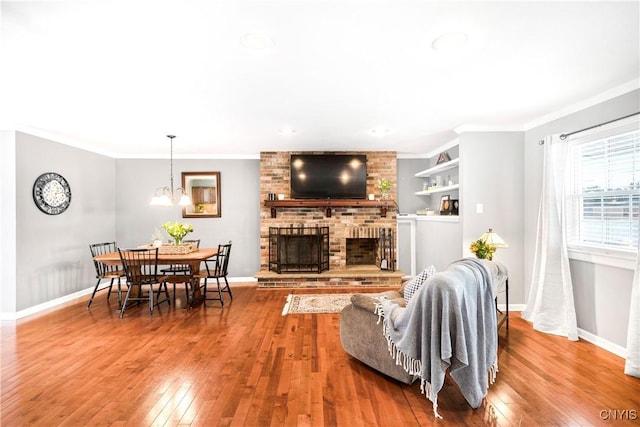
(459, 132), (526, 304)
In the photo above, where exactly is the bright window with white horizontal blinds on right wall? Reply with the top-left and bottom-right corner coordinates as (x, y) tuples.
(567, 127), (640, 252)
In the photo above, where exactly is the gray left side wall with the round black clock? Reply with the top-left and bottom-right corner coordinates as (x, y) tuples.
(14, 132), (116, 311)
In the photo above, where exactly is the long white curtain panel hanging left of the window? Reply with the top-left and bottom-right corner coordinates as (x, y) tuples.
(522, 135), (578, 341)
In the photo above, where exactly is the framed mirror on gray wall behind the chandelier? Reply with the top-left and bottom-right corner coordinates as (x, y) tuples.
(182, 172), (221, 218)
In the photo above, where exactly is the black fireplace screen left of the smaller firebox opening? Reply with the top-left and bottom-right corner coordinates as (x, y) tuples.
(269, 226), (329, 273)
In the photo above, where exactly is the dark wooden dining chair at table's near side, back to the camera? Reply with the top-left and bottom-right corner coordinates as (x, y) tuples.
(118, 248), (171, 318)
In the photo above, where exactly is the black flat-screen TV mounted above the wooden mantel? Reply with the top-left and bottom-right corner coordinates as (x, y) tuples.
(291, 154), (367, 199)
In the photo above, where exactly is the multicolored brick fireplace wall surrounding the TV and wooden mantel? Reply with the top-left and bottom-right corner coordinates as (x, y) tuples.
(257, 151), (401, 285)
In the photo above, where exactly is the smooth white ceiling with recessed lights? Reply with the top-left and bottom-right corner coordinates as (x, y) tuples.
(0, 0), (640, 157)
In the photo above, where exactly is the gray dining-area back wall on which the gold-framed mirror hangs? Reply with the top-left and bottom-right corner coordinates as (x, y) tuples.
(115, 159), (260, 277)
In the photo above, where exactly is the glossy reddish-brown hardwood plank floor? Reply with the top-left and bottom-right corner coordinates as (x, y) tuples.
(0, 284), (640, 426)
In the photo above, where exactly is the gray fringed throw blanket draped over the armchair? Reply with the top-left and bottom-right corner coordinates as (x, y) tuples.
(378, 258), (498, 418)
